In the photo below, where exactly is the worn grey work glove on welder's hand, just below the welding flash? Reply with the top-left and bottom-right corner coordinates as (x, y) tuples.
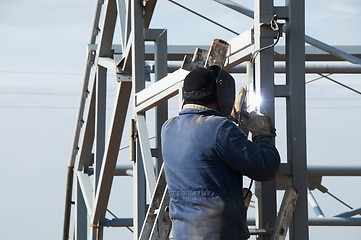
(247, 112), (276, 138)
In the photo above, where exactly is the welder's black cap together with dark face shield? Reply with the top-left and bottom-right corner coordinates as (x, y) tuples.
(183, 65), (235, 116)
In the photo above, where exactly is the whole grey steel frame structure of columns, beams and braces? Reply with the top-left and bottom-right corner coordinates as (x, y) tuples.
(63, 0), (361, 240)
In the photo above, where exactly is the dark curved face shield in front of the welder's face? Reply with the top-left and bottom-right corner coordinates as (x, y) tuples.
(208, 65), (236, 116)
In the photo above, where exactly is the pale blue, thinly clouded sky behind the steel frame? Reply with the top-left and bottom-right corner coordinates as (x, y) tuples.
(0, 0), (361, 240)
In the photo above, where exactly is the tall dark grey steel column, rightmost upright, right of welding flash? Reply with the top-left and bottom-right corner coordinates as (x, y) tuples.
(286, 0), (308, 240)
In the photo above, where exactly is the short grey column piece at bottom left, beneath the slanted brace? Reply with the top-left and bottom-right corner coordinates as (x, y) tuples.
(74, 179), (88, 240)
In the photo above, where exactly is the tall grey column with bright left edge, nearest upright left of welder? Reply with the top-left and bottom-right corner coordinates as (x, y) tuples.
(131, 1), (146, 239)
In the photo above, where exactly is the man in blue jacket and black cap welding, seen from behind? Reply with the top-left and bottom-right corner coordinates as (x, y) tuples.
(161, 65), (280, 240)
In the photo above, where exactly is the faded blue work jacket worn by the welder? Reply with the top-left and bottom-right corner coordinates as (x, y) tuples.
(161, 104), (280, 240)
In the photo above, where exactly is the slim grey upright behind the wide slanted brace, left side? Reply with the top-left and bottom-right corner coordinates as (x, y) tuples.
(92, 66), (107, 240)
